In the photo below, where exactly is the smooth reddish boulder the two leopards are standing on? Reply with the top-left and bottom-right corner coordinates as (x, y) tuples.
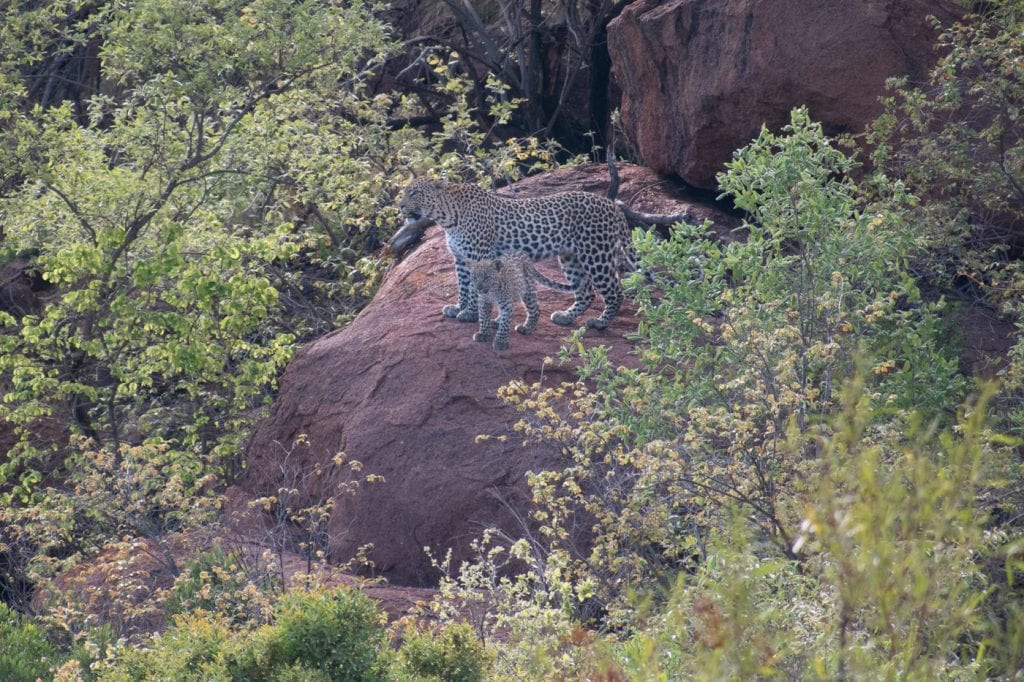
(241, 161), (728, 585)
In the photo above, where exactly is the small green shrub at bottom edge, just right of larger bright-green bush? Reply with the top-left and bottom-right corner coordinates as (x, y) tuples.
(396, 624), (487, 682)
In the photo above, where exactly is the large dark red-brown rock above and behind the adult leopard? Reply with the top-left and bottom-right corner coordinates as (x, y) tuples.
(608, 0), (957, 188)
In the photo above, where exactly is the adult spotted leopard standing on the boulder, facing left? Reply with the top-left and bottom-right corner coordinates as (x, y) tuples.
(398, 178), (636, 329)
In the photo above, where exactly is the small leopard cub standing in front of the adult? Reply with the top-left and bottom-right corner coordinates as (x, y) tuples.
(467, 252), (575, 350)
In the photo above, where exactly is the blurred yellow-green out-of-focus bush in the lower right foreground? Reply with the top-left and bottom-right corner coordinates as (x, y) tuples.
(803, 385), (999, 679)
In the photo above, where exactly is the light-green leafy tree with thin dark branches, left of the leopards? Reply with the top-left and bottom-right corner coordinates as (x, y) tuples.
(0, 2), (389, 494)
